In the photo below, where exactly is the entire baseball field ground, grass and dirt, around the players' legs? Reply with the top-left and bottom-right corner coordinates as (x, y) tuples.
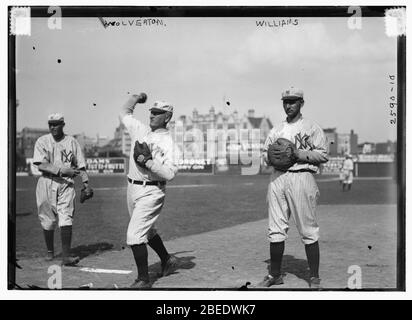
(16, 175), (397, 290)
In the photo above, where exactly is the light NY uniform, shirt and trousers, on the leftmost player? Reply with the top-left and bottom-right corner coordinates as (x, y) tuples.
(33, 134), (86, 230)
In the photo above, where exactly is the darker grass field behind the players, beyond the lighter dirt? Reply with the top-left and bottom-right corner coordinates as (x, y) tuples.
(16, 175), (397, 258)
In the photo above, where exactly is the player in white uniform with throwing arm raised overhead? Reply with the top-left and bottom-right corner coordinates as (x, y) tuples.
(120, 94), (178, 288)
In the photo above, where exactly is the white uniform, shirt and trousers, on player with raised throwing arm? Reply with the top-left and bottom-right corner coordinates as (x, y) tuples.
(121, 114), (179, 245)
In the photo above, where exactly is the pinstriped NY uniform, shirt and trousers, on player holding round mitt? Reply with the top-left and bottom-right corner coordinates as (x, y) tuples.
(263, 117), (328, 244)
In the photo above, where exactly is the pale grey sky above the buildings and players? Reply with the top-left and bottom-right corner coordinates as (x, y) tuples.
(16, 17), (396, 142)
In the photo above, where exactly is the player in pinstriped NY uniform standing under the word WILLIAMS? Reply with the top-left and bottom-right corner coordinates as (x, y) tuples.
(259, 87), (328, 288)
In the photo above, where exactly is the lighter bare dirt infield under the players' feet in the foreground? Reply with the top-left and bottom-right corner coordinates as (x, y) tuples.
(17, 205), (396, 290)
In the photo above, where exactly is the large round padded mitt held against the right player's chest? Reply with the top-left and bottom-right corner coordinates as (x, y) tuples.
(268, 138), (297, 171)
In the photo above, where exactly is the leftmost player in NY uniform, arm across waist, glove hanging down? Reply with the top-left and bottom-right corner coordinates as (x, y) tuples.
(33, 113), (89, 266)
